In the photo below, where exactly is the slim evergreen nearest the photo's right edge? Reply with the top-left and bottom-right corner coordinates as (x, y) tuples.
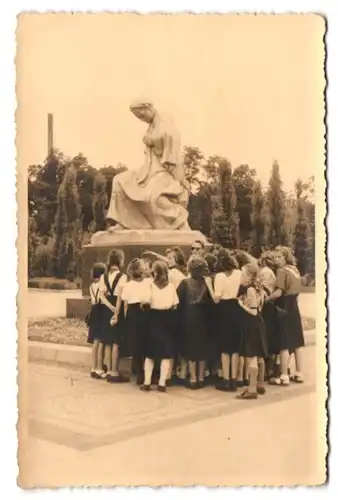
(294, 179), (310, 276)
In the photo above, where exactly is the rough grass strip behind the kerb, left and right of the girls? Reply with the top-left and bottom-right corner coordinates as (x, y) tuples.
(28, 318), (316, 346)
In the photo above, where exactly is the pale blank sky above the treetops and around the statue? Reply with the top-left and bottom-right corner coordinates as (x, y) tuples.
(17, 14), (324, 190)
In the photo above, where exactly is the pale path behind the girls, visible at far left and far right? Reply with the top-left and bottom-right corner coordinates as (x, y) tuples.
(27, 289), (316, 318)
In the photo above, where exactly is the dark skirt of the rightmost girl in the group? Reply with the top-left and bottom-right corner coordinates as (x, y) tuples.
(276, 295), (305, 353)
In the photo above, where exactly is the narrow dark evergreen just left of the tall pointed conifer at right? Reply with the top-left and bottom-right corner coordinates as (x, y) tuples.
(252, 181), (266, 258)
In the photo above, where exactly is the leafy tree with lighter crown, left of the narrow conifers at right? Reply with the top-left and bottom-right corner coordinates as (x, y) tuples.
(232, 165), (256, 242)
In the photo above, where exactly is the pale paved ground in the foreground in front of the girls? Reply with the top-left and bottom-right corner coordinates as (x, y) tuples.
(17, 347), (325, 487)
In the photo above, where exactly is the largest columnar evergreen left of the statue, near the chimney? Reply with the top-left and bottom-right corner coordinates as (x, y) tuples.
(53, 164), (82, 278)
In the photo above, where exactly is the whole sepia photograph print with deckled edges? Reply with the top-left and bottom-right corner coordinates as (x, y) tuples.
(16, 13), (328, 489)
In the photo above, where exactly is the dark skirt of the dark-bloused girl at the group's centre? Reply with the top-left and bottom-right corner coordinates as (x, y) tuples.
(182, 304), (208, 361)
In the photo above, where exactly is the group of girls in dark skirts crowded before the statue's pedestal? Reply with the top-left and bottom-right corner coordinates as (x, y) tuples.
(87, 240), (304, 399)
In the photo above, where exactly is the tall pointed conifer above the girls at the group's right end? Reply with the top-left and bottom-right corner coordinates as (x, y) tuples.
(267, 161), (286, 248)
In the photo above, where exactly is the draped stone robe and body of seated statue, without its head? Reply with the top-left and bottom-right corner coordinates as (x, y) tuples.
(107, 114), (189, 229)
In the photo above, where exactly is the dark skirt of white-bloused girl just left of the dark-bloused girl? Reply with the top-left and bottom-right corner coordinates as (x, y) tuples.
(144, 309), (176, 359)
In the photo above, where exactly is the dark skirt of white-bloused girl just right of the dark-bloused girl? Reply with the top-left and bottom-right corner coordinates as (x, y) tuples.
(216, 299), (241, 354)
